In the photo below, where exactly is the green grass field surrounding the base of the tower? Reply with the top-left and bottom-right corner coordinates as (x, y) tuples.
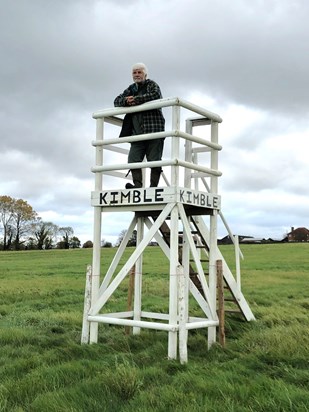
(0, 244), (309, 412)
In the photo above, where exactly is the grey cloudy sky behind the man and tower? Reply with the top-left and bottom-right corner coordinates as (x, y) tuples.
(0, 0), (309, 242)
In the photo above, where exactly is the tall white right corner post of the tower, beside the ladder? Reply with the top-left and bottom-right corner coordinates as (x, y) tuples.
(208, 121), (218, 347)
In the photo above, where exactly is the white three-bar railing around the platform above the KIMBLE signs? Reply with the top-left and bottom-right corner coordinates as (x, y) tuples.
(91, 97), (222, 193)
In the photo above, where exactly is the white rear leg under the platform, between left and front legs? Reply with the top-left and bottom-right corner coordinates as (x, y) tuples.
(133, 217), (144, 335)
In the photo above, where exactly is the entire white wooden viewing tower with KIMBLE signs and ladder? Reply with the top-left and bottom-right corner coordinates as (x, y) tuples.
(81, 98), (254, 363)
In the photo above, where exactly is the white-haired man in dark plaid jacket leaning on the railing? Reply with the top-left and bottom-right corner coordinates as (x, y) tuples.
(114, 63), (165, 189)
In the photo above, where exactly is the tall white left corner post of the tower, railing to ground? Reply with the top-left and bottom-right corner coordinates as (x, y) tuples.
(90, 119), (104, 343)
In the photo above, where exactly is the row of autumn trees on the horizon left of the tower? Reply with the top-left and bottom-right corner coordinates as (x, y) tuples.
(0, 196), (81, 250)
